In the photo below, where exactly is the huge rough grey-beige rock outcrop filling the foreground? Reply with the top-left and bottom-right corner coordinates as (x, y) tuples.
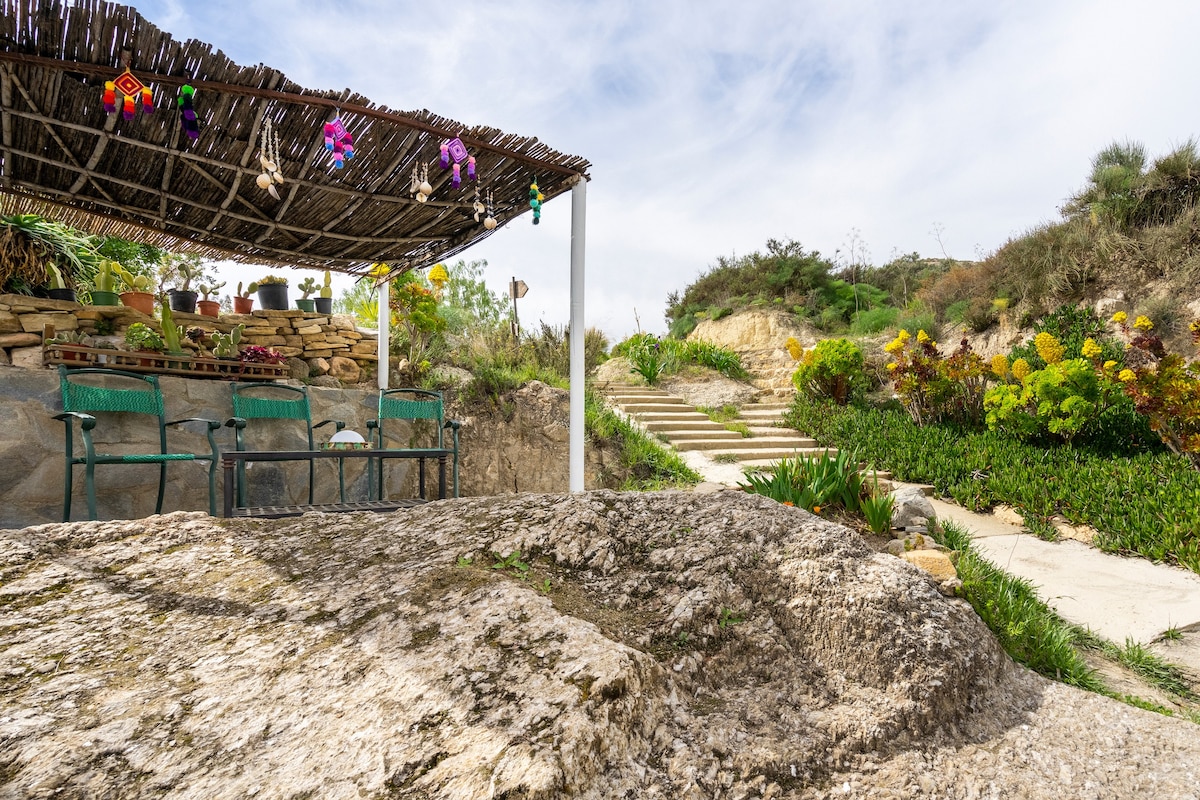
(0, 492), (1200, 800)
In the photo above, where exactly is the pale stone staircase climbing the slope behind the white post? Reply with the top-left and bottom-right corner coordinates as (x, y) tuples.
(598, 384), (836, 469)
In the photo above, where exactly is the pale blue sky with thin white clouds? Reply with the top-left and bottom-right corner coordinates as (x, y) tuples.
(133, 0), (1200, 343)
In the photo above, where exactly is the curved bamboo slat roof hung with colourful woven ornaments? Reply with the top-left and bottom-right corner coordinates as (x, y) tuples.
(0, 0), (590, 273)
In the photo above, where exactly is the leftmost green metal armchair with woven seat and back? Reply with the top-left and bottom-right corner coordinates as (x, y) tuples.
(54, 365), (221, 522)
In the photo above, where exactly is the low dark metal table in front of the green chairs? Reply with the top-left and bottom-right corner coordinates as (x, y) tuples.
(221, 447), (454, 518)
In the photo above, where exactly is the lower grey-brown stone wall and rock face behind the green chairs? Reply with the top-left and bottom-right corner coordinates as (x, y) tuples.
(0, 366), (620, 528)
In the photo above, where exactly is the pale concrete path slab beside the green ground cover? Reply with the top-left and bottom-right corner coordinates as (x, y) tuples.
(931, 499), (1200, 644)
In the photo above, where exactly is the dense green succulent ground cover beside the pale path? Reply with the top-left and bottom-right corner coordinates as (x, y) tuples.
(786, 396), (1200, 572)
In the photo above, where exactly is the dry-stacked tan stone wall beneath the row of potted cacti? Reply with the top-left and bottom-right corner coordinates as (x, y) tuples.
(0, 295), (379, 384)
